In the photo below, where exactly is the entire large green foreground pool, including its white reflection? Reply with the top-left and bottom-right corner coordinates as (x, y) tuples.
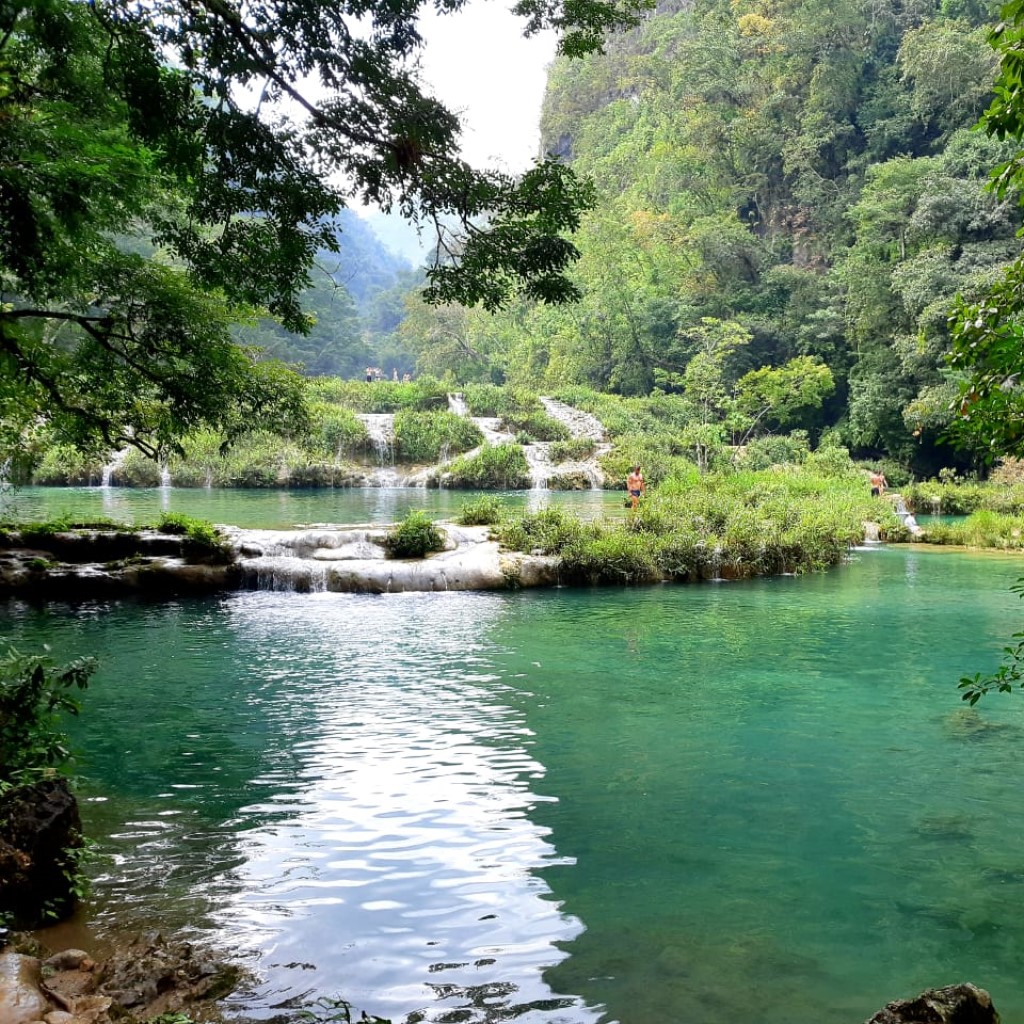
(2, 550), (1024, 1024)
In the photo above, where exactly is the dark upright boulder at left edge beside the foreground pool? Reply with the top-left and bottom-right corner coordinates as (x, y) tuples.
(0, 778), (82, 929)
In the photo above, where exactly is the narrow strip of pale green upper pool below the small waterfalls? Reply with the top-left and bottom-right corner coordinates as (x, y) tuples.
(0, 487), (623, 529)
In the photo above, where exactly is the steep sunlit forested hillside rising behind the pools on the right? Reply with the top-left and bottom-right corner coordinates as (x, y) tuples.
(402, 0), (1021, 473)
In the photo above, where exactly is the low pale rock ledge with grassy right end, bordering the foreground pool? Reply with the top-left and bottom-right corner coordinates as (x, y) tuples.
(0, 505), (897, 600)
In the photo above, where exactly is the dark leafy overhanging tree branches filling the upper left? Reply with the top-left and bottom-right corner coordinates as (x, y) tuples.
(0, 0), (644, 454)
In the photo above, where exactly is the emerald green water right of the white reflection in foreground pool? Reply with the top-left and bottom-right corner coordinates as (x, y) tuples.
(489, 552), (1024, 1024)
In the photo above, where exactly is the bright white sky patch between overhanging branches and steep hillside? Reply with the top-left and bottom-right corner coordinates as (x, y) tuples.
(421, 0), (555, 172)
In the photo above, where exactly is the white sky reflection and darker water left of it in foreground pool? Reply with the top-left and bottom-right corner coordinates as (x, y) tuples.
(0, 593), (596, 1024)
